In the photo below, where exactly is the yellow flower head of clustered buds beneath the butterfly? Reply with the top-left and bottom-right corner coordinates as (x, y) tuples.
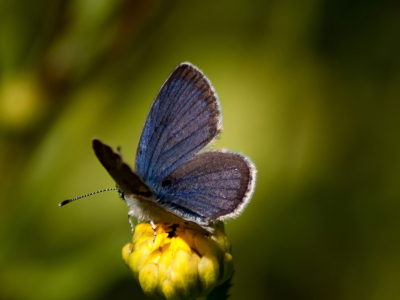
(122, 223), (233, 300)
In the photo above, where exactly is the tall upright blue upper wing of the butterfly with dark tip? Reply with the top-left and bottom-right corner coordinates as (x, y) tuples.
(135, 63), (222, 190)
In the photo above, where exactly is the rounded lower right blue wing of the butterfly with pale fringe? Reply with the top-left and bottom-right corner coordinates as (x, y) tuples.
(156, 151), (256, 224)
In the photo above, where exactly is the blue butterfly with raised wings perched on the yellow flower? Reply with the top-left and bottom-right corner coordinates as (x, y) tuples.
(60, 63), (256, 232)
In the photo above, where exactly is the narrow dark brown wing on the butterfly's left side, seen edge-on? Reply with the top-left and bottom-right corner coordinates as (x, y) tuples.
(93, 139), (153, 198)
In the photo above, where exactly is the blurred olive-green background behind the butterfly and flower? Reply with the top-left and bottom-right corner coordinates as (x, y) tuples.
(0, 0), (400, 300)
